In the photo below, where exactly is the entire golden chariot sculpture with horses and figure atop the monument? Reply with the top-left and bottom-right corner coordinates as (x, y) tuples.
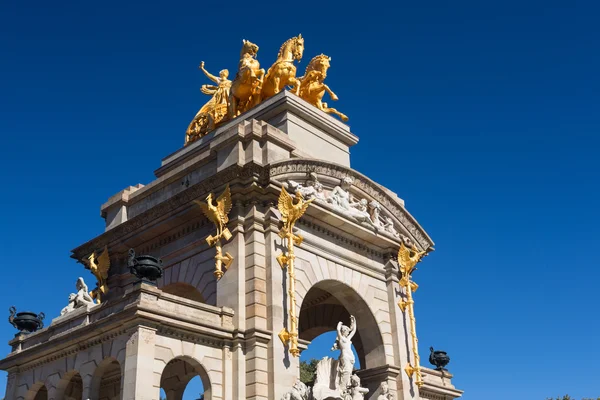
(185, 35), (348, 146)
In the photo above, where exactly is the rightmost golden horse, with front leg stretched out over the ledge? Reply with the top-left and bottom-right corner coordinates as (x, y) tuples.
(298, 54), (348, 121)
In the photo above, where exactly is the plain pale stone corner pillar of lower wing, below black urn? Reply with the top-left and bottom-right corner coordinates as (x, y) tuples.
(123, 326), (155, 400)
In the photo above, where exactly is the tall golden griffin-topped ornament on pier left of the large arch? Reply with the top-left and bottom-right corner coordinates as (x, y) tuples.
(277, 187), (314, 357)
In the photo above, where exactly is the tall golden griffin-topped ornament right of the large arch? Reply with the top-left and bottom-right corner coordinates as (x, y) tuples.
(398, 242), (426, 387)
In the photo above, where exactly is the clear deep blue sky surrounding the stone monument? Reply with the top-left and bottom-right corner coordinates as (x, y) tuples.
(0, 0), (600, 400)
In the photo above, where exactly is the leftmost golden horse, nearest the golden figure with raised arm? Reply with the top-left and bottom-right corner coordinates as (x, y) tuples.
(229, 39), (265, 118)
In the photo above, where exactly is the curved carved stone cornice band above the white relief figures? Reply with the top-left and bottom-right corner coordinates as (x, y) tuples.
(269, 158), (434, 250)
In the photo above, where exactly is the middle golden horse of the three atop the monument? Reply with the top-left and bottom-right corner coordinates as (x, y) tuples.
(262, 35), (304, 100)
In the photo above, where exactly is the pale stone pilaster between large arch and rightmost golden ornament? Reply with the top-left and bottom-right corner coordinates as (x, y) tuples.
(384, 260), (419, 400)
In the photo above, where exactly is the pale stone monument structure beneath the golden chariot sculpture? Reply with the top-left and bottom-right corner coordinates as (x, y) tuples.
(0, 90), (462, 400)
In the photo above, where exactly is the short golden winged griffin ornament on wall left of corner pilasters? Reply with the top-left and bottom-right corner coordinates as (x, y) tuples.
(194, 186), (233, 280)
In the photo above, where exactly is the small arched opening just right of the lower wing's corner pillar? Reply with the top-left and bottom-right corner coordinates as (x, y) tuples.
(160, 357), (212, 400)
